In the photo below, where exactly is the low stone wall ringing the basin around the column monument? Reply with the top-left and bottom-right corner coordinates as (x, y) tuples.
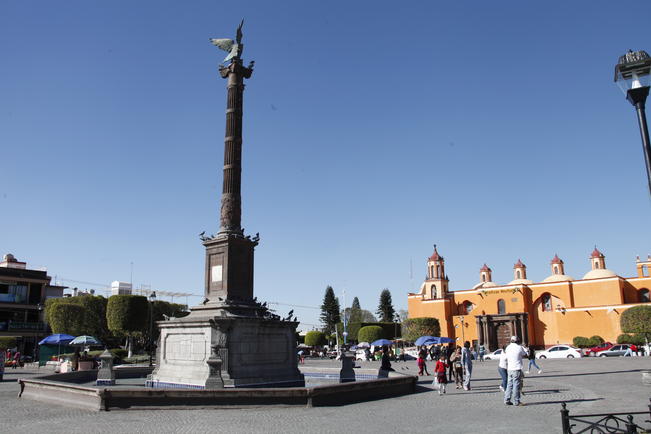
(19, 368), (417, 410)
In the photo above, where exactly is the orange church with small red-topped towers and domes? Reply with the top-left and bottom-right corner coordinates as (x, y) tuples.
(408, 246), (651, 351)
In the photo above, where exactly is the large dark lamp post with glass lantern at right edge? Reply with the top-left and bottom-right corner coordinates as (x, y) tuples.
(615, 50), (651, 194)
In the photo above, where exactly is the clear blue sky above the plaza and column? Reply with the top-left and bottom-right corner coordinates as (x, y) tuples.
(0, 0), (651, 328)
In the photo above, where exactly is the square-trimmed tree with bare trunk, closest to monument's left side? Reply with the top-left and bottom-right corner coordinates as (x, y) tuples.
(106, 295), (149, 357)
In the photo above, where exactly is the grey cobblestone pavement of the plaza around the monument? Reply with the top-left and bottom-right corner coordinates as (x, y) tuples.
(0, 357), (651, 434)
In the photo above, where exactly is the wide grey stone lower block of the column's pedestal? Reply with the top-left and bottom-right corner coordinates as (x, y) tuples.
(147, 306), (305, 389)
